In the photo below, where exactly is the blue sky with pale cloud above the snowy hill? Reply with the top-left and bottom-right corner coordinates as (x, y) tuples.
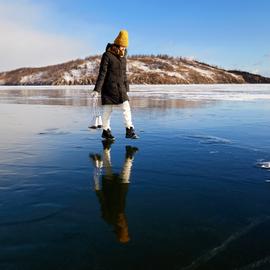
(0, 0), (270, 76)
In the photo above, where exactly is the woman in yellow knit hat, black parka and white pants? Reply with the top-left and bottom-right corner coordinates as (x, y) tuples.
(91, 30), (138, 140)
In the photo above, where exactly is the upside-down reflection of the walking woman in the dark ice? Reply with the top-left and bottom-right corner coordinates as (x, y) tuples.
(90, 141), (138, 243)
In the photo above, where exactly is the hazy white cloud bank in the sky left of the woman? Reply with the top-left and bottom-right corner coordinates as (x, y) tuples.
(0, 0), (90, 71)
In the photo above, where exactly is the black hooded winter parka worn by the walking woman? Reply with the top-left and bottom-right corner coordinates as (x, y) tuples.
(94, 43), (129, 105)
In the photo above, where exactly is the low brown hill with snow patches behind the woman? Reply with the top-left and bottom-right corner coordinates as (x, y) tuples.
(0, 55), (270, 85)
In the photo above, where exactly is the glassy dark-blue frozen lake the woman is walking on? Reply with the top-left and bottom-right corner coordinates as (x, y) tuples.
(0, 85), (270, 270)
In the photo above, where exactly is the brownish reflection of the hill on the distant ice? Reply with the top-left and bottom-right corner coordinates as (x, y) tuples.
(0, 86), (207, 108)
